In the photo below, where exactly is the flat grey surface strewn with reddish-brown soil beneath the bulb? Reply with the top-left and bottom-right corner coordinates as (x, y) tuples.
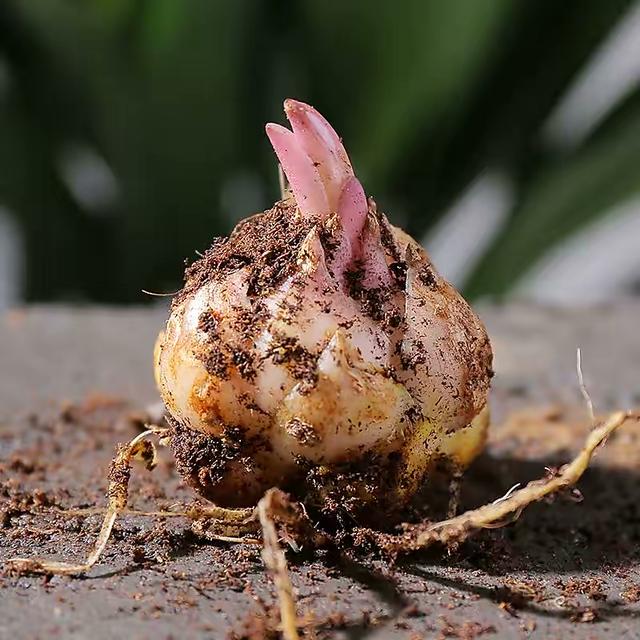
(0, 302), (640, 640)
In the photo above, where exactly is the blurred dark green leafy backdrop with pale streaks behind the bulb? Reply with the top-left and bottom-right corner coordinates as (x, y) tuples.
(0, 0), (640, 308)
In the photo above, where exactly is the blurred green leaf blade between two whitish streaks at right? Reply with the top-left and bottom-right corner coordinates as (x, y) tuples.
(466, 90), (640, 296)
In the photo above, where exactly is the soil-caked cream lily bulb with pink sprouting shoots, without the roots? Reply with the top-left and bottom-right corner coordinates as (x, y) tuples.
(155, 100), (492, 507)
